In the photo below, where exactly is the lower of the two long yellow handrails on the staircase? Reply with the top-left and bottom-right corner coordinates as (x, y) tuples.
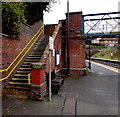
(0, 26), (43, 81)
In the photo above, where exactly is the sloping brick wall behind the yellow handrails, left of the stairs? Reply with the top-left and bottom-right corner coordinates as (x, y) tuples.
(2, 21), (42, 69)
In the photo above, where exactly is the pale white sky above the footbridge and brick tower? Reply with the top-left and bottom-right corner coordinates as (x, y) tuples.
(44, 0), (120, 24)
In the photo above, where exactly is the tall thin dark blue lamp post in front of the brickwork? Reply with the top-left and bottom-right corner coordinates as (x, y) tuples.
(67, 0), (70, 75)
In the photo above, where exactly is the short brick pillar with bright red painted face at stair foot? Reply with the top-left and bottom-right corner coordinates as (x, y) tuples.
(31, 63), (47, 100)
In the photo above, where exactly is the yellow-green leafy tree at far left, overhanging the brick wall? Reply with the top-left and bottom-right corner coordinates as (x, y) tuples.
(2, 2), (26, 39)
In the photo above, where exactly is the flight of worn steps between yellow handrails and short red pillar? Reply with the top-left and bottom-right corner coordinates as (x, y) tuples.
(3, 36), (48, 98)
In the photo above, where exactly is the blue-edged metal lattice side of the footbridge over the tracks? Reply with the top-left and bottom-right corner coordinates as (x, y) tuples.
(82, 12), (120, 38)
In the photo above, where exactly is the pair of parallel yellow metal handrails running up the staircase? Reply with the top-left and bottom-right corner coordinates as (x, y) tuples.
(0, 25), (44, 81)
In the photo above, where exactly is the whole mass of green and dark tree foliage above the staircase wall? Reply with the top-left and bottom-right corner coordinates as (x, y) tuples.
(2, 0), (57, 39)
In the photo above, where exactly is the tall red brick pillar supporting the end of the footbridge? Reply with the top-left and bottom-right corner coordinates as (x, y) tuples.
(66, 12), (86, 76)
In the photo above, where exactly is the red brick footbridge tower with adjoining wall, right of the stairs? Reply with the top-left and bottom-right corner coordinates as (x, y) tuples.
(45, 12), (86, 76)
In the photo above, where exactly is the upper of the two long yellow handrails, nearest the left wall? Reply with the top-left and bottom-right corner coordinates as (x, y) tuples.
(0, 25), (44, 72)
